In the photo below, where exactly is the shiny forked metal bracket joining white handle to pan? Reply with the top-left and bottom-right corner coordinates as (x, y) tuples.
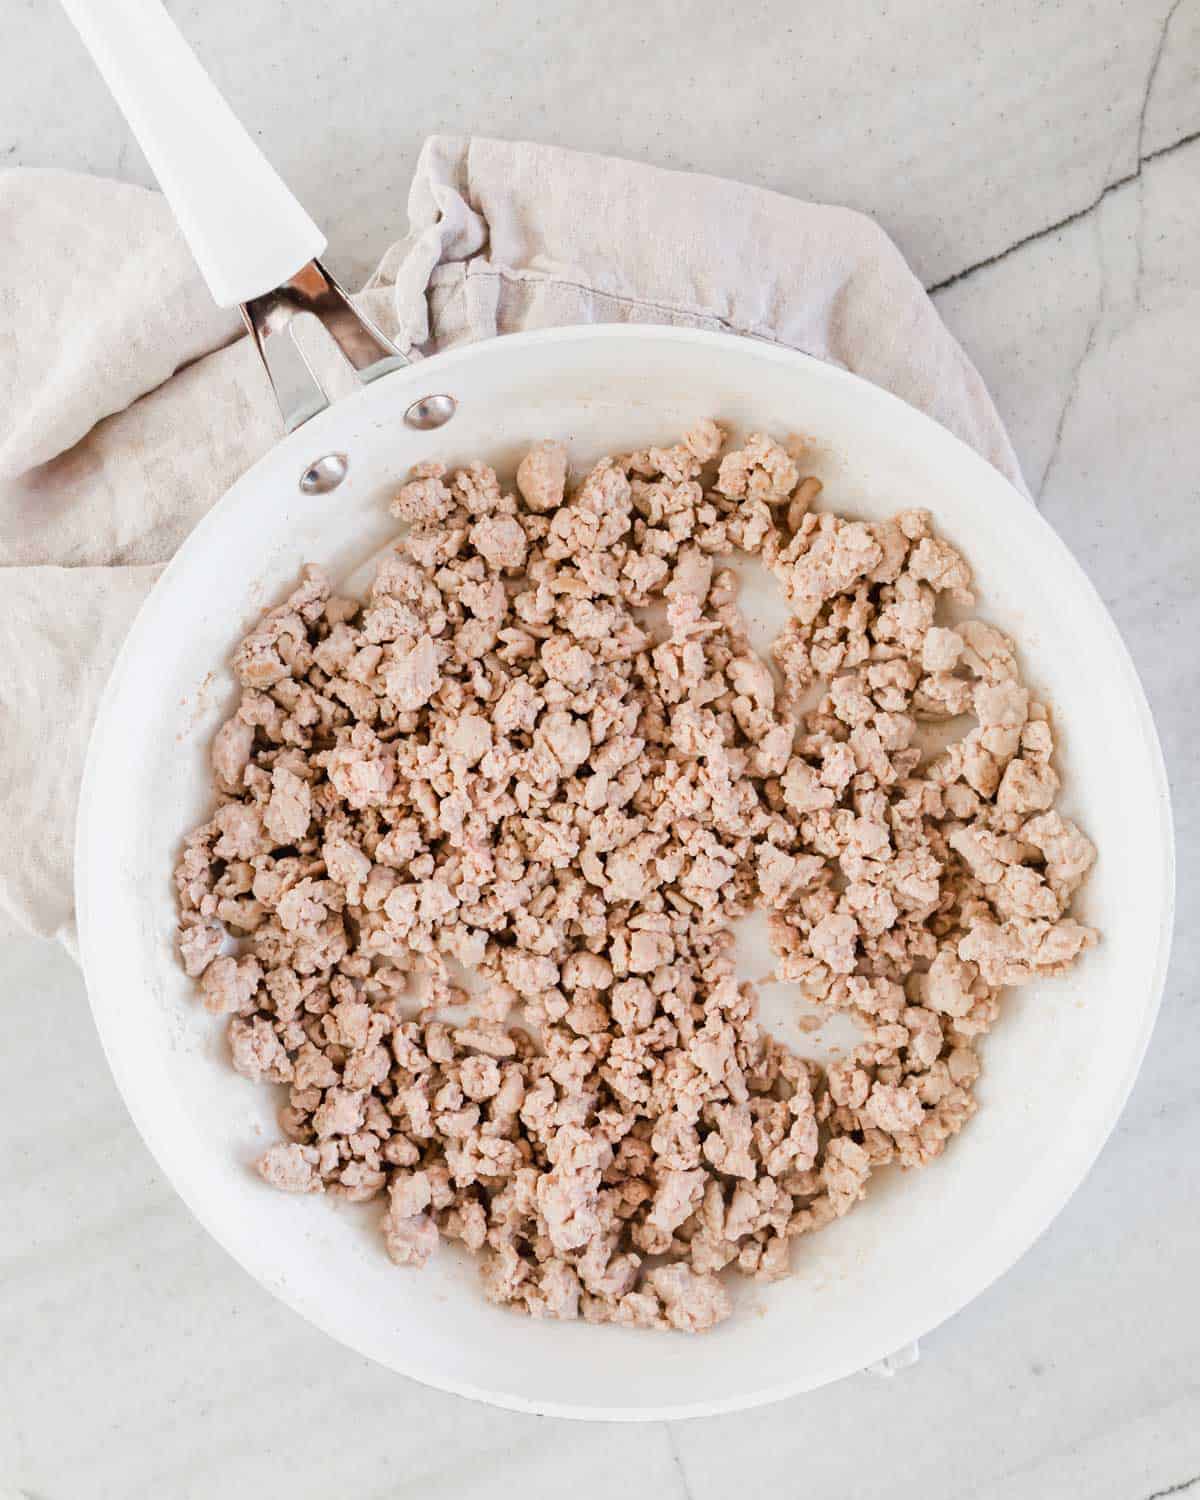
(242, 261), (410, 432)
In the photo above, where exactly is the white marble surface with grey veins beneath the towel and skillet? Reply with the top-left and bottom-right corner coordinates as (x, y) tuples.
(0, 0), (1200, 1500)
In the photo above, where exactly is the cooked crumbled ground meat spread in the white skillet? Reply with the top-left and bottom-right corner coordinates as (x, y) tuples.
(176, 422), (1095, 1331)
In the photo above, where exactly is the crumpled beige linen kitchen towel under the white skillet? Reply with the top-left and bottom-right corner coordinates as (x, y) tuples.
(0, 137), (1022, 939)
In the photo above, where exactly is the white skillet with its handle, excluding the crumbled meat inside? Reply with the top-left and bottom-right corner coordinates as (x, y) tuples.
(68, 0), (1173, 1421)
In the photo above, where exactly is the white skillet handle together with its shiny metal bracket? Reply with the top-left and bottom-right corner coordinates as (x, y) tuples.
(62, 0), (408, 432)
